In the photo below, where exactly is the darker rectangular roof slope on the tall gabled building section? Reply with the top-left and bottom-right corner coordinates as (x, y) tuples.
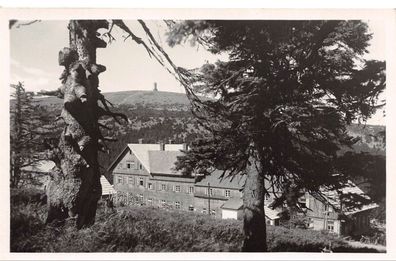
(148, 151), (183, 175)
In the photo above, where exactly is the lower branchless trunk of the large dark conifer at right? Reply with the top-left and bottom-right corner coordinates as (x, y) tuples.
(242, 154), (267, 252)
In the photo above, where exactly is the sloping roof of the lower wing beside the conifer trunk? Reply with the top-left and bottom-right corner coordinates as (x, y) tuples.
(195, 170), (246, 189)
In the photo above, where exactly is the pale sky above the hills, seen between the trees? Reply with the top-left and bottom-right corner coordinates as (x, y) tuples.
(10, 20), (386, 125)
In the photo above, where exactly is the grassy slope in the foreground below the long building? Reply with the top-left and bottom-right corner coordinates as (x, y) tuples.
(11, 190), (376, 252)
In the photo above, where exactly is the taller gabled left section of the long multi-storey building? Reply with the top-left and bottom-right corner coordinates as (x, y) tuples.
(109, 144), (195, 210)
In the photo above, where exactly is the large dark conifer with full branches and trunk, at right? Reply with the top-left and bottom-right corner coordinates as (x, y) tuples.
(168, 20), (385, 252)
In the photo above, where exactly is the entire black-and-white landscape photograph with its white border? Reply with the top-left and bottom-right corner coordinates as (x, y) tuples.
(2, 9), (396, 259)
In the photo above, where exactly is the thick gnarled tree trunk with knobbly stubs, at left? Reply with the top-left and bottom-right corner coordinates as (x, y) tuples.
(47, 20), (108, 228)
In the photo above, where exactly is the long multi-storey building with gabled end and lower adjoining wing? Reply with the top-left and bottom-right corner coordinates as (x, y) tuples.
(108, 143), (256, 218)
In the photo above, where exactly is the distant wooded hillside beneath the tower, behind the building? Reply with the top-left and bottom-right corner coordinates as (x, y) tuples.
(21, 91), (385, 181)
